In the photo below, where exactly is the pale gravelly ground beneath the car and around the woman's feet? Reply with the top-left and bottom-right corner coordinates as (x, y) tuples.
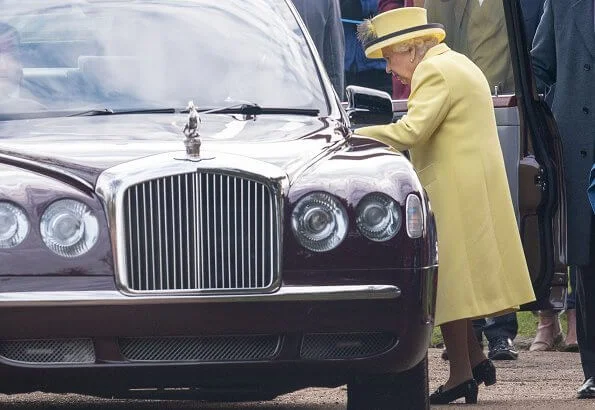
(0, 349), (595, 410)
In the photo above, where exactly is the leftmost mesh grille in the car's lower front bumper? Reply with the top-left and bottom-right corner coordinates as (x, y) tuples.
(0, 339), (95, 364)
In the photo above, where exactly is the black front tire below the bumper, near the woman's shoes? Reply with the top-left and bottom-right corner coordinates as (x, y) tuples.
(347, 356), (430, 410)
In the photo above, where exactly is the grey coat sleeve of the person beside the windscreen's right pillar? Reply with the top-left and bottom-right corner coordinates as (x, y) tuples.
(324, 0), (345, 100)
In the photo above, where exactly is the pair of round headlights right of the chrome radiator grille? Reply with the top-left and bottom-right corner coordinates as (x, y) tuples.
(291, 192), (414, 252)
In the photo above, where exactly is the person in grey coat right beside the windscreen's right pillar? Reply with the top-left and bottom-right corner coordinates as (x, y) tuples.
(293, 0), (345, 100)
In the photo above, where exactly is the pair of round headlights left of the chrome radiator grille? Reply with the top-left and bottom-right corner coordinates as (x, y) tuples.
(0, 199), (99, 258)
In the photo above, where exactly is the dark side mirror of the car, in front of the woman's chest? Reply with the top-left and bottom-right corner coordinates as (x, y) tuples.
(345, 85), (393, 126)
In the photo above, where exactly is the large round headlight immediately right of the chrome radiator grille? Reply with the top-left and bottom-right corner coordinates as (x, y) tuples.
(291, 192), (348, 252)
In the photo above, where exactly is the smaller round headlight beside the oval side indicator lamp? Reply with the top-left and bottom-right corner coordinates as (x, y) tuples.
(356, 193), (401, 242)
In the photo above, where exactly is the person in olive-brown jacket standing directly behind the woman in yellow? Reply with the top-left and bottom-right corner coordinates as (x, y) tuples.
(425, 0), (520, 360)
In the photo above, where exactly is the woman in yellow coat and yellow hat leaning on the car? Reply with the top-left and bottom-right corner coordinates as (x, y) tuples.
(356, 7), (535, 404)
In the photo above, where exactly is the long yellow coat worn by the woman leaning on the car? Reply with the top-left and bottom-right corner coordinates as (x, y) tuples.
(356, 44), (535, 325)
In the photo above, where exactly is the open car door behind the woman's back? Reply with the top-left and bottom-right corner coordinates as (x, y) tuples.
(494, 0), (567, 309)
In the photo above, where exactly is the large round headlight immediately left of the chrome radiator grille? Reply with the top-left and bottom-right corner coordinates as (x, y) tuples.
(40, 199), (99, 258)
